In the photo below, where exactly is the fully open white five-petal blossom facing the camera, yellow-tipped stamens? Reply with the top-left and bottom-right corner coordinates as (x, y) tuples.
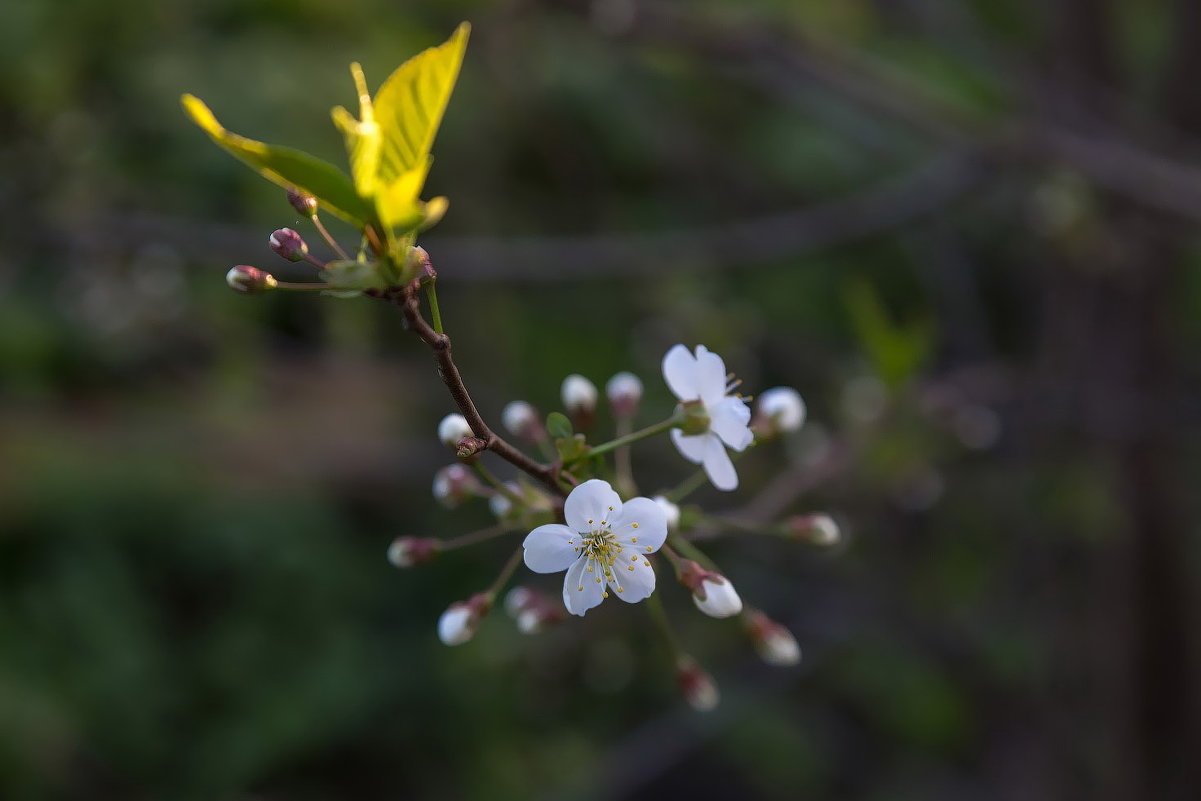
(524, 478), (668, 615)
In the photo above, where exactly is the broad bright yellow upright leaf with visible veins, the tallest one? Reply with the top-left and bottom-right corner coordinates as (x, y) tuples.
(375, 23), (471, 188)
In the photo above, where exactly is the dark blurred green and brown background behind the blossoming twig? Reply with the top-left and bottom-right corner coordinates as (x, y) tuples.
(0, 0), (1201, 801)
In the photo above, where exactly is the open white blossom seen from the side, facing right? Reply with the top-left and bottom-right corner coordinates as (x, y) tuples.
(663, 345), (754, 490)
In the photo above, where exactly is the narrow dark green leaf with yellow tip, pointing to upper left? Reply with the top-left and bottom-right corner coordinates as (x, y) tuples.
(181, 95), (375, 226)
